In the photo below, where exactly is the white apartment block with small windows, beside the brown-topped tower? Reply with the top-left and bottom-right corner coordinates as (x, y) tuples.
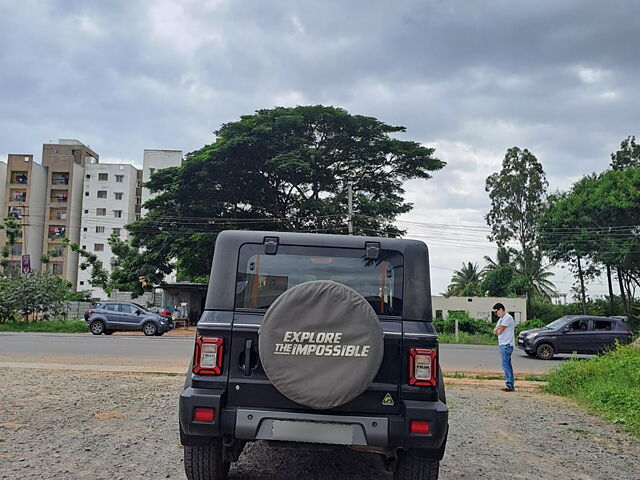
(76, 162), (138, 298)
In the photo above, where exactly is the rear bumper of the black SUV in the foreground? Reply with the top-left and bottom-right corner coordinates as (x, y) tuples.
(180, 387), (449, 458)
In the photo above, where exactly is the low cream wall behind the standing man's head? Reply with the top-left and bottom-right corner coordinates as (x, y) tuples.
(431, 296), (527, 323)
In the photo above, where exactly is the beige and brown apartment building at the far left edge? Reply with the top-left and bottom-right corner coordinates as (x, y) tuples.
(0, 154), (47, 270)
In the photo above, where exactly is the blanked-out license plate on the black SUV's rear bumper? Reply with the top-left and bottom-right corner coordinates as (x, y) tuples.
(272, 420), (354, 445)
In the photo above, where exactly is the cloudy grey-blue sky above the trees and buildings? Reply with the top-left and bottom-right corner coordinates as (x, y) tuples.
(0, 0), (640, 294)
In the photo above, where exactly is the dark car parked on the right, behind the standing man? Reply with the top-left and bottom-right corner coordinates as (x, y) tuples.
(518, 315), (633, 360)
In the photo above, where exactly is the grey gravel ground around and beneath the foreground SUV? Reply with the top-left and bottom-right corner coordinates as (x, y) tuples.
(0, 368), (640, 480)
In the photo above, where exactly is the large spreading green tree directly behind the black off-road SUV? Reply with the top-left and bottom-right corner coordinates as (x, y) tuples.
(129, 106), (445, 278)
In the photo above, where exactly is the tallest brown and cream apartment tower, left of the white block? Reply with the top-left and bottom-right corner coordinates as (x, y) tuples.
(42, 139), (99, 285)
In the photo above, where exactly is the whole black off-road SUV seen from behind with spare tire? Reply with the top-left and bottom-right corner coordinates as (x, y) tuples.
(179, 231), (448, 480)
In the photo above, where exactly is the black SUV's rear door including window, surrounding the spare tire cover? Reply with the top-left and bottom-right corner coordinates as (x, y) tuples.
(222, 244), (403, 414)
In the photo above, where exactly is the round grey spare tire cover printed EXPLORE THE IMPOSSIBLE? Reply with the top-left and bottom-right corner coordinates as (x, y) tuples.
(258, 280), (384, 409)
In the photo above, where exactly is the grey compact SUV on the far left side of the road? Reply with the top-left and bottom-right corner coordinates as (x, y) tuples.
(84, 302), (170, 336)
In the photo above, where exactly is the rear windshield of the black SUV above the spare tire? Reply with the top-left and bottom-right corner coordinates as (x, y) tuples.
(236, 244), (403, 316)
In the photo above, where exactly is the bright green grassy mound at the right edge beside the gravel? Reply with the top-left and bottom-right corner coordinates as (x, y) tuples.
(545, 345), (640, 437)
